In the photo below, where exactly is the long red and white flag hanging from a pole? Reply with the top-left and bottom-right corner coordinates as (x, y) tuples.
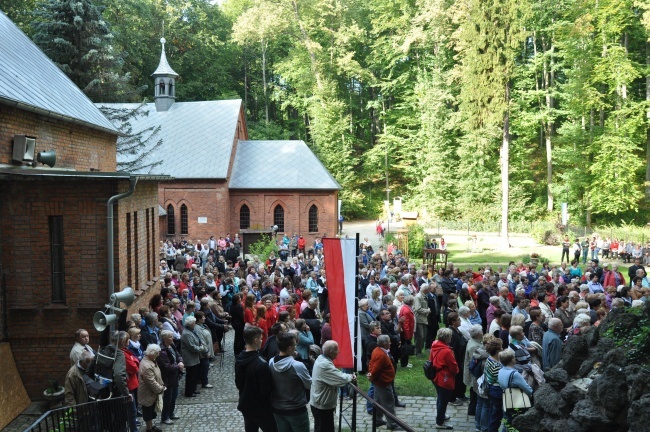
(323, 238), (362, 370)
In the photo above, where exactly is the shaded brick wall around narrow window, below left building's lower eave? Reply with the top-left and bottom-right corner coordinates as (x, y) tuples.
(0, 180), (113, 398)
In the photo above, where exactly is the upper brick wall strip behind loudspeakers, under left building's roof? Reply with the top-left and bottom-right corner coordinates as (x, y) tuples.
(0, 105), (117, 171)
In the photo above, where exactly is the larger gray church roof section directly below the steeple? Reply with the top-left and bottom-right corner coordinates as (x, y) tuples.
(97, 99), (242, 179)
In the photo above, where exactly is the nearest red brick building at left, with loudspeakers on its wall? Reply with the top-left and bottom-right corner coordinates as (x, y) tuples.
(0, 12), (161, 408)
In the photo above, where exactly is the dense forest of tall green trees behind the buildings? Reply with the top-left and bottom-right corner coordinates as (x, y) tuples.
(0, 0), (650, 232)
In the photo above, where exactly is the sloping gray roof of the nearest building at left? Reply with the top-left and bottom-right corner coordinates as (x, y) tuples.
(0, 11), (117, 134)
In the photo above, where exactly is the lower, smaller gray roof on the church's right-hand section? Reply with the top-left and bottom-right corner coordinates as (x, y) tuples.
(229, 141), (341, 190)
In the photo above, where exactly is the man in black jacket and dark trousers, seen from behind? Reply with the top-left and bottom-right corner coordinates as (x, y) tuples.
(235, 326), (278, 432)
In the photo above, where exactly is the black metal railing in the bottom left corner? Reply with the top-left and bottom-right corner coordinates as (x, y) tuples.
(24, 397), (131, 432)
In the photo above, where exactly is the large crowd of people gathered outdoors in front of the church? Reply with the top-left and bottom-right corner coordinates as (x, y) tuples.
(66, 231), (650, 432)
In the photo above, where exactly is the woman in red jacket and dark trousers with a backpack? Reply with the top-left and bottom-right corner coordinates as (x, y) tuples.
(429, 328), (459, 430)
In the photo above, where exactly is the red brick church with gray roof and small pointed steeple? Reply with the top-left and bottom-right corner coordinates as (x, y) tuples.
(102, 40), (340, 248)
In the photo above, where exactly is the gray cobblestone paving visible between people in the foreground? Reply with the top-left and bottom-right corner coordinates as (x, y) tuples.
(4, 332), (474, 432)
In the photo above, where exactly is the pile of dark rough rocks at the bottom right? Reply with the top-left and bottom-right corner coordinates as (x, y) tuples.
(513, 306), (650, 432)
